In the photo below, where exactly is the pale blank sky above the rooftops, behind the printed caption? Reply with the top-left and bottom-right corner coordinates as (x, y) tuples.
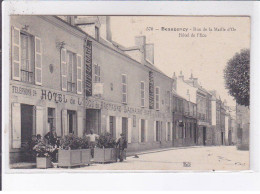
(107, 16), (250, 106)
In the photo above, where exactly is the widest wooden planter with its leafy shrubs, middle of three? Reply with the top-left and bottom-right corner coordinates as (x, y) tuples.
(58, 135), (91, 167)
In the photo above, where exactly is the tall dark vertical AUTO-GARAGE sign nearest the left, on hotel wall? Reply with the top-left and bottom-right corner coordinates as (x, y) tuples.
(85, 40), (92, 96)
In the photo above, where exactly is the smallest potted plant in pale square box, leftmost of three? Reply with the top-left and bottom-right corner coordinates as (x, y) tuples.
(33, 141), (56, 168)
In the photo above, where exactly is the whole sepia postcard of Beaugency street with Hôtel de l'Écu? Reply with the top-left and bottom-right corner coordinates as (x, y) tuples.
(8, 15), (250, 172)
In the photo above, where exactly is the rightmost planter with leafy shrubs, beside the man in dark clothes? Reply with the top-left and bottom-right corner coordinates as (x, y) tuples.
(94, 132), (117, 163)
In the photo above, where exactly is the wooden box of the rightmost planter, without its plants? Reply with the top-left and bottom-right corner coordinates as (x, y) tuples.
(94, 148), (117, 163)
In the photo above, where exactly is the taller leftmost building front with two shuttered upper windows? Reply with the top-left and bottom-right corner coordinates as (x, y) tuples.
(9, 16), (85, 163)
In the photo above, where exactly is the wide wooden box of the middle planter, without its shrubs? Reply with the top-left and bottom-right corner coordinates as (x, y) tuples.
(58, 149), (91, 167)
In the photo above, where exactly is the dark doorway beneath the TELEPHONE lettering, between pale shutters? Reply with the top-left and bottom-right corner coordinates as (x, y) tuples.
(21, 104), (35, 147)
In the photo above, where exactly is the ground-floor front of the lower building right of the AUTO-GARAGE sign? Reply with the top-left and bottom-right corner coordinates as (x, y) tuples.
(85, 97), (172, 151)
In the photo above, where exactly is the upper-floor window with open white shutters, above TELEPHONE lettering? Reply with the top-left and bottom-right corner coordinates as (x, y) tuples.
(12, 27), (42, 85)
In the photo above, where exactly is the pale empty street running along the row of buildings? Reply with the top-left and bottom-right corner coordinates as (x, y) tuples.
(57, 146), (249, 170)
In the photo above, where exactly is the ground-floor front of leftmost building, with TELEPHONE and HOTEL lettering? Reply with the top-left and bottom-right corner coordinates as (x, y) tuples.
(10, 81), (85, 162)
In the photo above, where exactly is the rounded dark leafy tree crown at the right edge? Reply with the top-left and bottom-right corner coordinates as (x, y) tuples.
(224, 49), (250, 106)
